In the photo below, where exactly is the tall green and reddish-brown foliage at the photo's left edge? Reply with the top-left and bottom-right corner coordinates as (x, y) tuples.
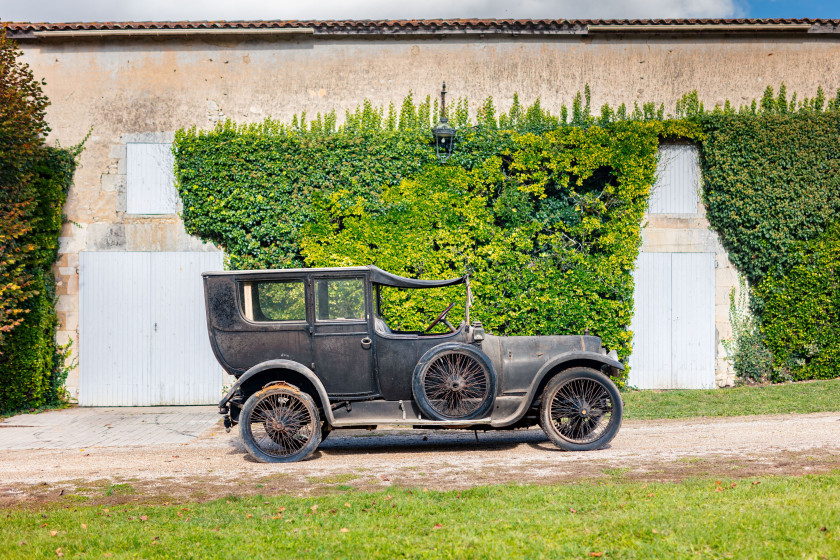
(0, 29), (75, 412)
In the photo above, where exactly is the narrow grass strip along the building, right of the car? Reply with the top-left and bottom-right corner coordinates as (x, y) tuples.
(621, 379), (840, 420)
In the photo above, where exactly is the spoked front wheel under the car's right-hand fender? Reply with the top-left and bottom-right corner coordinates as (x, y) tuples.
(540, 367), (623, 451)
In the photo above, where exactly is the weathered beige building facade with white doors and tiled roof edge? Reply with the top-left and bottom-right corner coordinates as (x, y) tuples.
(7, 20), (840, 405)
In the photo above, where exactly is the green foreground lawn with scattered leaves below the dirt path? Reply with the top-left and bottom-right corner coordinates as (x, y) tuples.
(0, 472), (840, 559)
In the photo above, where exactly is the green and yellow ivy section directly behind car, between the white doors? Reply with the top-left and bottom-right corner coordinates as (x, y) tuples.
(175, 96), (700, 380)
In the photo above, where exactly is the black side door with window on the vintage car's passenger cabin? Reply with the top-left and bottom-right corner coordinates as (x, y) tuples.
(312, 275), (377, 397)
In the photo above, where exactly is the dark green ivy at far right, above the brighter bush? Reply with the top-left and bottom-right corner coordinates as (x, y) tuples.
(702, 111), (840, 285)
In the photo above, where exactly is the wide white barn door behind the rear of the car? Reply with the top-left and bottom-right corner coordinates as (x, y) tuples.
(79, 252), (223, 406)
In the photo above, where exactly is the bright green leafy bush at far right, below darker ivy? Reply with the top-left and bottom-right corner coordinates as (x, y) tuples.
(756, 222), (840, 380)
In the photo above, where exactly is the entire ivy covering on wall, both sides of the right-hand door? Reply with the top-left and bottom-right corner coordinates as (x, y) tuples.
(175, 87), (840, 380)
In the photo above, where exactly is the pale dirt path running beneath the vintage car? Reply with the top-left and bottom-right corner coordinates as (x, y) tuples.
(0, 413), (840, 504)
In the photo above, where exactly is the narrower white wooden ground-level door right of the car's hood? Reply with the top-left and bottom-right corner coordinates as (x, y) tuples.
(628, 253), (715, 389)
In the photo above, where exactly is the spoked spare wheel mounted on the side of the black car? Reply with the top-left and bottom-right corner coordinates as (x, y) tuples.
(412, 343), (496, 420)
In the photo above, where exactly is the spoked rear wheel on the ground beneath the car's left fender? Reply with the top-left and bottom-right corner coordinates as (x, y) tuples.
(239, 385), (321, 463)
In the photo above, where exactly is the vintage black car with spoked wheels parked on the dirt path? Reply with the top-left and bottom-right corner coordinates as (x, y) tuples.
(203, 266), (623, 462)
